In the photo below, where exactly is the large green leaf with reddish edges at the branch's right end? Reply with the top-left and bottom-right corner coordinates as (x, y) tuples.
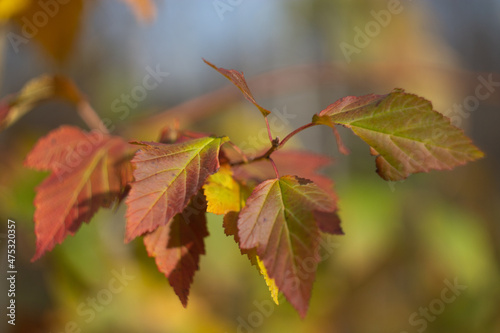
(313, 89), (484, 181)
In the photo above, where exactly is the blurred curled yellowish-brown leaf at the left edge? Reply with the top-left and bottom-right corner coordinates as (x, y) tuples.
(0, 75), (83, 130)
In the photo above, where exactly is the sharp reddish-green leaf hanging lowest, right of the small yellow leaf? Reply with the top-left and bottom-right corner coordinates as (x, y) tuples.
(238, 176), (336, 317)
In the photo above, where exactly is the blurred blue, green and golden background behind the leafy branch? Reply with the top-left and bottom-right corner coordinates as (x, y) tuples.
(0, 0), (500, 333)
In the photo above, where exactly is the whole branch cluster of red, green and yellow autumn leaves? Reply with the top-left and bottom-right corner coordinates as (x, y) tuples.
(0, 61), (483, 317)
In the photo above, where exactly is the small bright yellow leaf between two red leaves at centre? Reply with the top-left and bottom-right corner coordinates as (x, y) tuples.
(203, 165), (241, 215)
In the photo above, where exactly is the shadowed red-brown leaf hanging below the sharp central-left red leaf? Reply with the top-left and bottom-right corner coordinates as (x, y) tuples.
(144, 194), (208, 307)
